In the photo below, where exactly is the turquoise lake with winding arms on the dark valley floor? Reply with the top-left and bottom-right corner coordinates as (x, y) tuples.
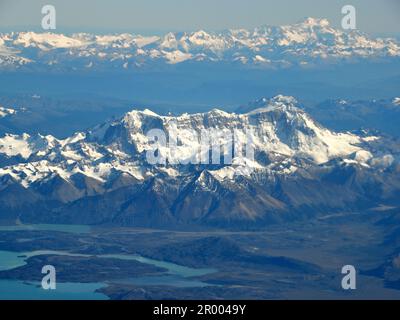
(0, 225), (216, 300)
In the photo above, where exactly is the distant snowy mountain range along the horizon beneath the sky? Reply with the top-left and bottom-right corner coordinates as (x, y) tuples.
(0, 18), (400, 70)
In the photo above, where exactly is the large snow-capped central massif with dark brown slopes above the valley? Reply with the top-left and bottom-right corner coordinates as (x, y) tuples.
(0, 96), (400, 226)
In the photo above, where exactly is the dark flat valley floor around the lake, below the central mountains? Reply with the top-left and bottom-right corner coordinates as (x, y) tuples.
(0, 209), (400, 299)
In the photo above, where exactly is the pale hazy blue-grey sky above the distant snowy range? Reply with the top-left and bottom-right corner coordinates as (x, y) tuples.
(0, 0), (400, 34)
